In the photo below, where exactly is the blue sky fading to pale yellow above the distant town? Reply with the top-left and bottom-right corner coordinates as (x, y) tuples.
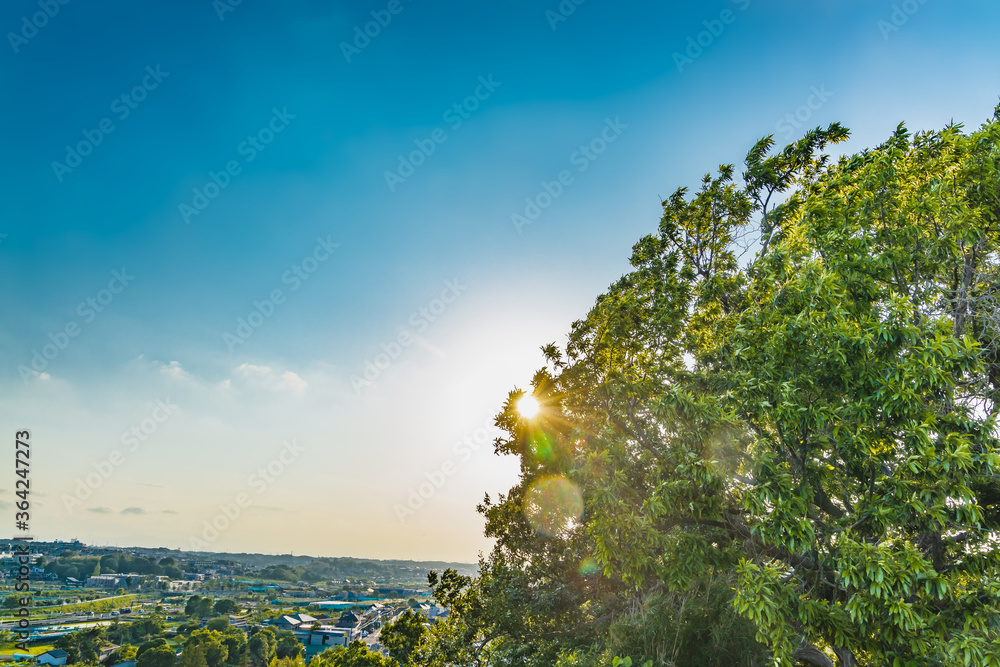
(0, 0), (1000, 560)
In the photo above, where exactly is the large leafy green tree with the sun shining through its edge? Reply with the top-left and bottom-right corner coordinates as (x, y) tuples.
(460, 108), (1000, 667)
